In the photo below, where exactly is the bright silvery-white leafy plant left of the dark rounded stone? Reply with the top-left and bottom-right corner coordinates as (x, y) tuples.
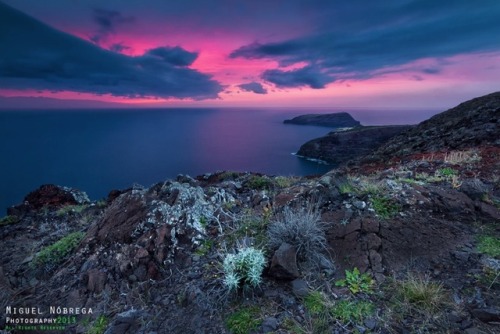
(222, 247), (266, 291)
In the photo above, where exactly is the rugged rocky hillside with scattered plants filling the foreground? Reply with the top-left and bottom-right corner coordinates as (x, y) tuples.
(0, 93), (500, 334)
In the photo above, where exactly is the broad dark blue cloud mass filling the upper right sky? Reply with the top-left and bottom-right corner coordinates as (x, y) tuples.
(230, 0), (500, 88)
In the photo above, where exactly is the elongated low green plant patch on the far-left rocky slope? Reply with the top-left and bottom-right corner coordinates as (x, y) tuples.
(32, 232), (85, 268)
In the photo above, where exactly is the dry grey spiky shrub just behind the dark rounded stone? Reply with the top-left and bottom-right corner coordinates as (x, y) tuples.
(268, 207), (330, 264)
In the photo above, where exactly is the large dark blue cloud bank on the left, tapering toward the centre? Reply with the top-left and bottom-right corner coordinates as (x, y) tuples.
(0, 3), (222, 99)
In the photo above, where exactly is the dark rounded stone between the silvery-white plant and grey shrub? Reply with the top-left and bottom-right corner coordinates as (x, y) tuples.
(269, 242), (300, 279)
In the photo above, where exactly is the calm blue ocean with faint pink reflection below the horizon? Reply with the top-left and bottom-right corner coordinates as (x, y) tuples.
(0, 108), (435, 213)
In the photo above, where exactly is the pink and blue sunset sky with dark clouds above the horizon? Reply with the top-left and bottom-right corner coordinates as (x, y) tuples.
(0, 0), (500, 109)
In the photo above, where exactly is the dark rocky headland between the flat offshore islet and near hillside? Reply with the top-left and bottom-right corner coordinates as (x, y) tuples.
(297, 125), (410, 164)
